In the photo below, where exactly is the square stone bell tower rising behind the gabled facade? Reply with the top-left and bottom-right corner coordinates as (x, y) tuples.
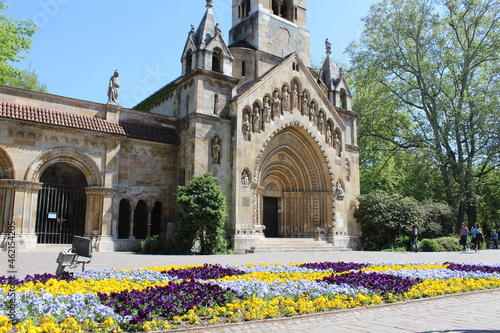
(229, 0), (311, 81)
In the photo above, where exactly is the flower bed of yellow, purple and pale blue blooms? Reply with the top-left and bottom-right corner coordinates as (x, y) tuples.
(0, 262), (500, 332)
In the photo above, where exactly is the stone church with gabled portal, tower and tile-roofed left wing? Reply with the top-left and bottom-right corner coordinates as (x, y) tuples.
(0, 0), (360, 253)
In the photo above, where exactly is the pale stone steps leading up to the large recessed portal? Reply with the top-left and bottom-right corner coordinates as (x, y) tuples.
(247, 238), (351, 253)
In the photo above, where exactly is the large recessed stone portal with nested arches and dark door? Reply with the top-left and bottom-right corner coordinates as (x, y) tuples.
(256, 125), (334, 238)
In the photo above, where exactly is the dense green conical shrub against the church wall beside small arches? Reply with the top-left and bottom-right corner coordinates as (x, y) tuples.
(177, 172), (227, 254)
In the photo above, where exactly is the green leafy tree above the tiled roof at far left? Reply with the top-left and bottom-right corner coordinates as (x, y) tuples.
(0, 0), (47, 91)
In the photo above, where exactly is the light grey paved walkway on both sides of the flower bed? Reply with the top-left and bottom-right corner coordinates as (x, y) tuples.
(0, 250), (500, 333)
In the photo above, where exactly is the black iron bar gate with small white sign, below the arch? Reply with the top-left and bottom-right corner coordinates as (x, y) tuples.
(35, 183), (86, 244)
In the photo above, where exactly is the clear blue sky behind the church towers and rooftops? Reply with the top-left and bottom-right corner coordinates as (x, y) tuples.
(4, 0), (377, 107)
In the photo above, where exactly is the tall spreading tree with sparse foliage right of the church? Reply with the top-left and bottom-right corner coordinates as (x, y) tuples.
(347, 0), (500, 225)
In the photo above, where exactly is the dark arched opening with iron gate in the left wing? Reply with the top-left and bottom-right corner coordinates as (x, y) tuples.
(35, 162), (87, 244)
